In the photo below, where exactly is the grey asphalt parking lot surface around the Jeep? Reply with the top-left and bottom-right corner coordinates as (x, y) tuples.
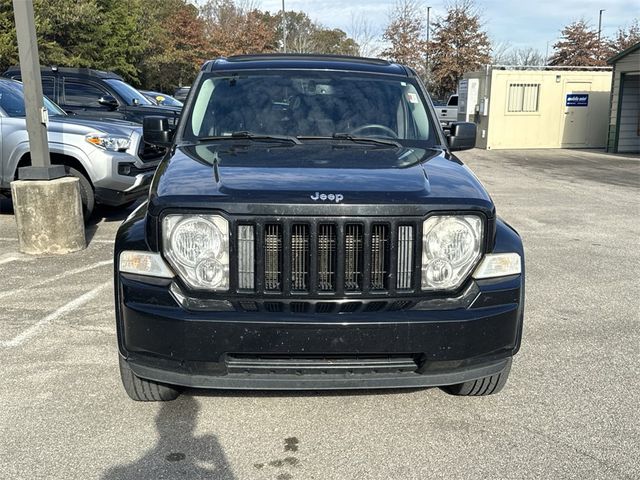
(0, 150), (640, 480)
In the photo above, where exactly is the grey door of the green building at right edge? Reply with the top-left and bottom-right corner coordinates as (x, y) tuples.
(617, 74), (640, 153)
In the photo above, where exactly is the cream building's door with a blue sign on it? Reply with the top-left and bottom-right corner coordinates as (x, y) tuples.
(560, 82), (591, 147)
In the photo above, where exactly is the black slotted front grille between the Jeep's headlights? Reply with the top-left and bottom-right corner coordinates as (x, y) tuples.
(232, 217), (421, 296)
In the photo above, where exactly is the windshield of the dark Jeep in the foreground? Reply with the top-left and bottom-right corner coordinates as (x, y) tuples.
(183, 71), (439, 147)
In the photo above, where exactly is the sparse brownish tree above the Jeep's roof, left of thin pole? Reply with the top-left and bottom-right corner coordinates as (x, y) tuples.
(381, 0), (427, 75)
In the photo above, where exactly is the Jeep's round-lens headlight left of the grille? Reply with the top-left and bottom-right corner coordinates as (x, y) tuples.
(162, 215), (229, 291)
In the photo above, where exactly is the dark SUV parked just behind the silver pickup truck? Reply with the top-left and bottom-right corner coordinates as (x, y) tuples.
(4, 67), (181, 123)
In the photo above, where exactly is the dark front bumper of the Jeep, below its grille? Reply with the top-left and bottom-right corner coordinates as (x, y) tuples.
(116, 273), (523, 389)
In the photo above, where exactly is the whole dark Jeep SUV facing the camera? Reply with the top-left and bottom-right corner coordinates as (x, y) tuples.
(115, 55), (524, 400)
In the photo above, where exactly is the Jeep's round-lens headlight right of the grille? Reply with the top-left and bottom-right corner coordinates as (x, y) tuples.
(422, 215), (483, 290)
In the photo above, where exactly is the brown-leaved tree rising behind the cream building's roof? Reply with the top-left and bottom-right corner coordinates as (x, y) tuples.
(549, 19), (612, 67)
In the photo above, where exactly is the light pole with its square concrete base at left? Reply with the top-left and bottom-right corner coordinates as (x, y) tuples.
(11, 0), (86, 255)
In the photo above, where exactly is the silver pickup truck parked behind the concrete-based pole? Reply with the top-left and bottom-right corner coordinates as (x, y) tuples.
(0, 78), (165, 219)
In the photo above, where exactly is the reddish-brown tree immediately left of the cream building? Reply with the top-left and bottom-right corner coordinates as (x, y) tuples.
(429, 0), (491, 97)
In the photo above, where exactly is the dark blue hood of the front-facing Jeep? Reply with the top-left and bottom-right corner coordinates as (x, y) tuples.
(151, 141), (492, 212)
